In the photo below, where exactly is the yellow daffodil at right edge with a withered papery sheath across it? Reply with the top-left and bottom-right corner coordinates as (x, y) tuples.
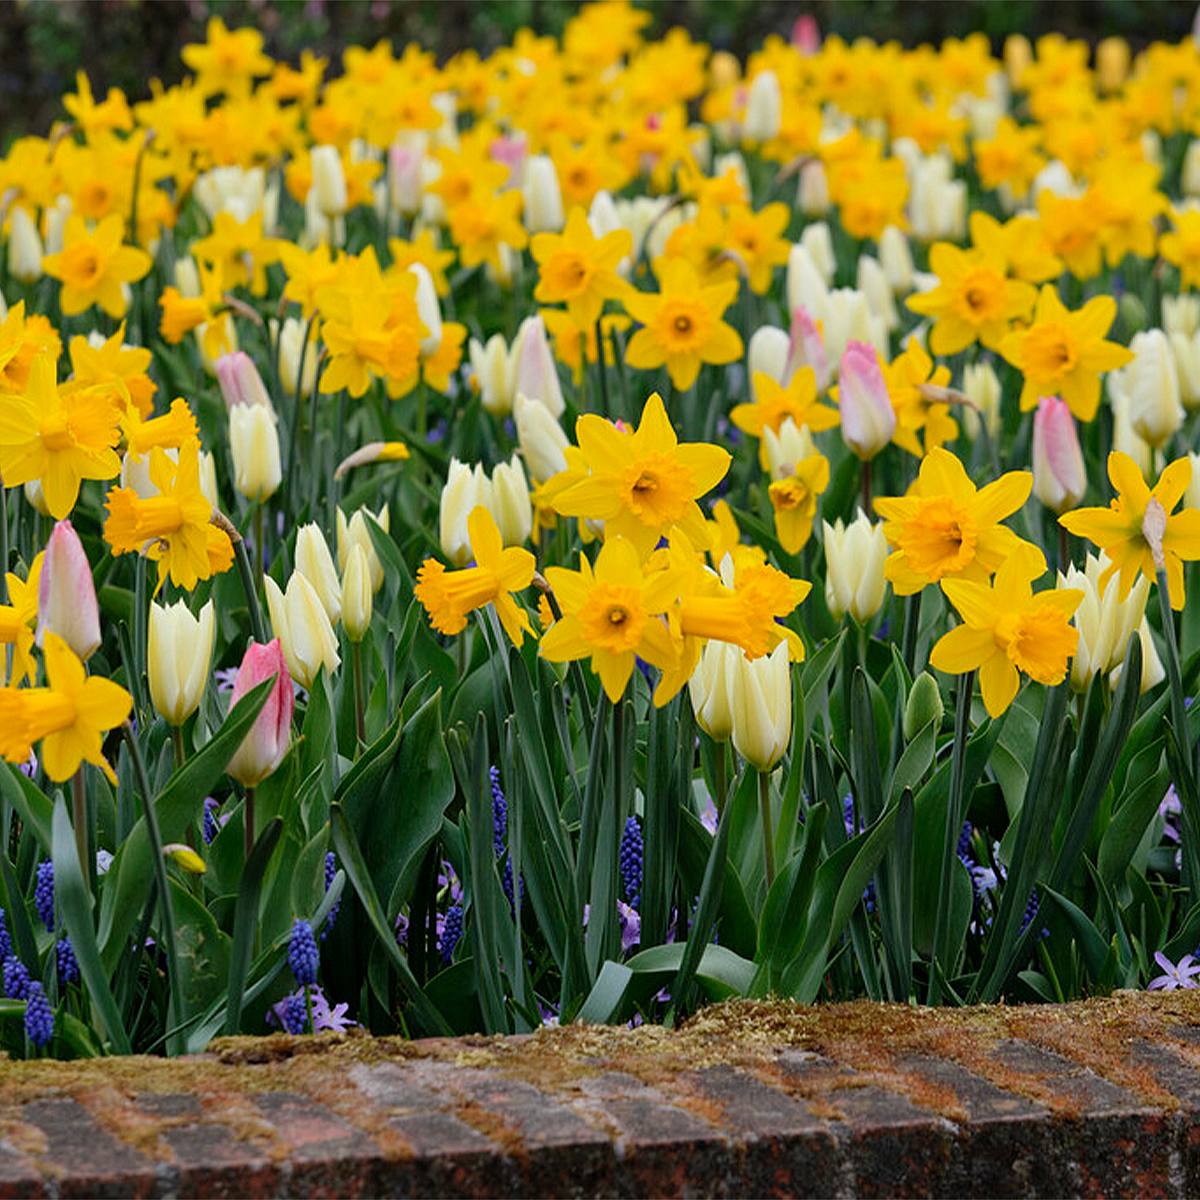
(1058, 450), (1200, 611)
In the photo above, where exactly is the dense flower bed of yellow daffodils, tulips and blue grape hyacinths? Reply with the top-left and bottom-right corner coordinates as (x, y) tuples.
(0, 2), (1200, 1058)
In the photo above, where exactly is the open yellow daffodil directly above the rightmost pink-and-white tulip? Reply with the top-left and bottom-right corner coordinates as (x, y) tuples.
(1000, 284), (1133, 421)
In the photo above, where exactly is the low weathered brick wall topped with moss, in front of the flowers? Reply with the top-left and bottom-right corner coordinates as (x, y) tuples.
(7, 995), (1200, 1198)
